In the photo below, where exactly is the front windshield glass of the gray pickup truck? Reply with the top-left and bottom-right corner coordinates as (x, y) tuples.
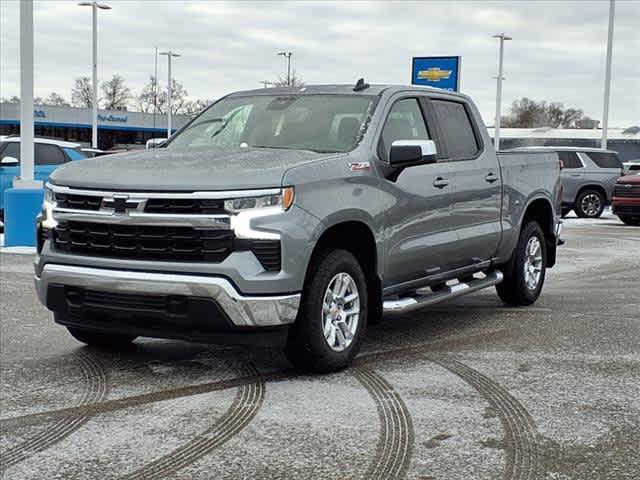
(167, 95), (375, 152)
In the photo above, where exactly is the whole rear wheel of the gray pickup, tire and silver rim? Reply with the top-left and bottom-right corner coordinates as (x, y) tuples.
(496, 221), (547, 306)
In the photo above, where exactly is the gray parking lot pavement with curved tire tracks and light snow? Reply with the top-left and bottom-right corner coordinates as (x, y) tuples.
(0, 215), (640, 480)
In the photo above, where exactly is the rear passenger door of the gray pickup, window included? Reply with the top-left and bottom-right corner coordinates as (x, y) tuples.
(431, 97), (502, 267)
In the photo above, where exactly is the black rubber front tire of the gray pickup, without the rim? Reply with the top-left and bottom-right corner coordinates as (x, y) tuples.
(285, 250), (369, 373)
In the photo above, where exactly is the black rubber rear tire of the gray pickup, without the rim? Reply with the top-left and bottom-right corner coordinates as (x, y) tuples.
(496, 221), (547, 306)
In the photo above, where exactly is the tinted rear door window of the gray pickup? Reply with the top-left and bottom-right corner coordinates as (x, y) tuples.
(431, 100), (480, 160)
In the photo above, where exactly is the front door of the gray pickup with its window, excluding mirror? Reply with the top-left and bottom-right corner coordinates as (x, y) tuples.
(378, 95), (456, 287)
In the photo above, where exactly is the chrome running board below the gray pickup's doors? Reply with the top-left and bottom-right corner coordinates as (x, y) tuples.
(382, 270), (504, 313)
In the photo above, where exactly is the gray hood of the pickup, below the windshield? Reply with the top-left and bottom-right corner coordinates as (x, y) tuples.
(50, 148), (327, 191)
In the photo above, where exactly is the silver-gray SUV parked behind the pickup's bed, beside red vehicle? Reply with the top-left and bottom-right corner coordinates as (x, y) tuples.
(515, 146), (624, 218)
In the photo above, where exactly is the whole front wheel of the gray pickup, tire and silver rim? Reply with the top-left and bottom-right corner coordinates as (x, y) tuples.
(285, 250), (369, 372)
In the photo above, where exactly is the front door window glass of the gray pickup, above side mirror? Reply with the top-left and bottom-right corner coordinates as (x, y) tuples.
(380, 98), (431, 161)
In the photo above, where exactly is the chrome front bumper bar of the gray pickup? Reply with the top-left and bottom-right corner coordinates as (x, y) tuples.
(35, 263), (300, 329)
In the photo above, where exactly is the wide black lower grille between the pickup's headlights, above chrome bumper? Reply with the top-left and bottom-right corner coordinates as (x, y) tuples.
(54, 221), (234, 263)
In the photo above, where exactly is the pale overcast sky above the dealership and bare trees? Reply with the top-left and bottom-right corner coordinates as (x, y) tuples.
(0, 0), (640, 127)
